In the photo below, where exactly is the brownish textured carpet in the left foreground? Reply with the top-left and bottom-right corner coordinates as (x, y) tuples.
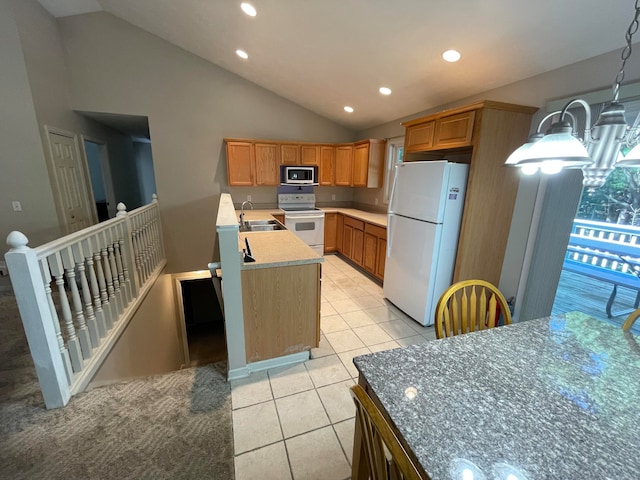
(0, 289), (234, 480)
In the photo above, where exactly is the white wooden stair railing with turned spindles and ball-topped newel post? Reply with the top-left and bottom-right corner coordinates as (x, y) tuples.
(5, 195), (166, 408)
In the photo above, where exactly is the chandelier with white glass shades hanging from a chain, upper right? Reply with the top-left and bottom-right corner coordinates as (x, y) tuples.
(505, 0), (640, 189)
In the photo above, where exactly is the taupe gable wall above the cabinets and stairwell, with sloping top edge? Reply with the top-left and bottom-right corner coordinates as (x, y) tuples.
(59, 13), (353, 272)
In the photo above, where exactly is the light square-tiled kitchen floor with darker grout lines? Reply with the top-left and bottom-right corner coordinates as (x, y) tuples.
(231, 255), (435, 480)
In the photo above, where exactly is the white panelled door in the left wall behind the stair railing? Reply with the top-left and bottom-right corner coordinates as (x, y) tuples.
(45, 127), (96, 234)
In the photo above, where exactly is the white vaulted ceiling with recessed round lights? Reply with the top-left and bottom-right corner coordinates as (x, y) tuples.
(39, 0), (634, 130)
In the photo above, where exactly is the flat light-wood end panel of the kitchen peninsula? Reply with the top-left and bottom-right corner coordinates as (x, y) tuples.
(241, 263), (320, 363)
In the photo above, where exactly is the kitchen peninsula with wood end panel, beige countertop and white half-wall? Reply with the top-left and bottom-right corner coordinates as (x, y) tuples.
(215, 194), (323, 379)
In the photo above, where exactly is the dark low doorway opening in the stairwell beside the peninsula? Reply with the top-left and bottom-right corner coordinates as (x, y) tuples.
(180, 278), (227, 367)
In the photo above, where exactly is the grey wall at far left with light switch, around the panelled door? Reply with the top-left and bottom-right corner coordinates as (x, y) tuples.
(0, 0), (143, 246)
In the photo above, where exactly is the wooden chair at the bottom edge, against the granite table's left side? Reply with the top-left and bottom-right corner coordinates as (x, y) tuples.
(351, 385), (422, 480)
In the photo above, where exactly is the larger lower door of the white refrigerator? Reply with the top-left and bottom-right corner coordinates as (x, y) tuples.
(383, 214), (442, 325)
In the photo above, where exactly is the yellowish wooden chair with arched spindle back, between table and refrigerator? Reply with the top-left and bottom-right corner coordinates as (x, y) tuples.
(435, 280), (511, 338)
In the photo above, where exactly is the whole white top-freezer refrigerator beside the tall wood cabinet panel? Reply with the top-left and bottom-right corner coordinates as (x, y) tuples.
(383, 160), (468, 325)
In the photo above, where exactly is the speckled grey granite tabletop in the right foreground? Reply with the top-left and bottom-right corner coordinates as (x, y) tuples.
(352, 312), (640, 480)
